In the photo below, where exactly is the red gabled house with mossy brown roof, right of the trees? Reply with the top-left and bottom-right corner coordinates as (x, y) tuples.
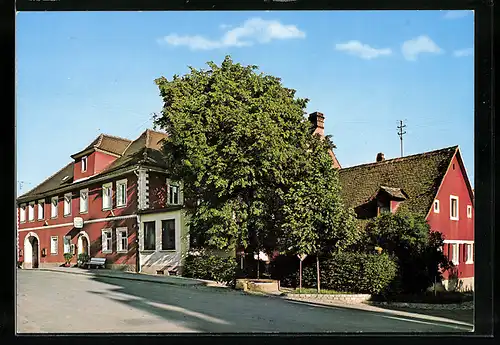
(339, 146), (474, 289)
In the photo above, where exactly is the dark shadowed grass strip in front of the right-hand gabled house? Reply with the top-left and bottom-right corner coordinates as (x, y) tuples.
(371, 291), (474, 304)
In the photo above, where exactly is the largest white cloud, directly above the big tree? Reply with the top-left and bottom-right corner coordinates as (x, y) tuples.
(159, 18), (306, 50)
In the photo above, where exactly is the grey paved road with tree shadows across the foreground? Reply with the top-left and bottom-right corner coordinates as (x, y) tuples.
(17, 270), (472, 333)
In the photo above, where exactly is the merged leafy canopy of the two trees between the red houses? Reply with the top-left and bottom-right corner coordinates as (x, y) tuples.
(154, 57), (353, 253)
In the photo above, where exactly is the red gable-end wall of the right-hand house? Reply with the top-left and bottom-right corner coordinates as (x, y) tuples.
(427, 156), (474, 277)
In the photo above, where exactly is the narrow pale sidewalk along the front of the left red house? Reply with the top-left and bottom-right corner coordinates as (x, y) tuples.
(38, 267), (223, 287)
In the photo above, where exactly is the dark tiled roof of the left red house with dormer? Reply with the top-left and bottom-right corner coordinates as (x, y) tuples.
(18, 129), (167, 202)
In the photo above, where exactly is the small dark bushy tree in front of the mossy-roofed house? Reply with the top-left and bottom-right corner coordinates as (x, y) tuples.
(366, 213), (449, 293)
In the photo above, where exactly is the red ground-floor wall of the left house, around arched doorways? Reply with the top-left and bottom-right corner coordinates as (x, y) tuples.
(19, 218), (137, 265)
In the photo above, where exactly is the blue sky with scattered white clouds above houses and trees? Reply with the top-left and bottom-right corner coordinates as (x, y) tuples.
(16, 11), (474, 193)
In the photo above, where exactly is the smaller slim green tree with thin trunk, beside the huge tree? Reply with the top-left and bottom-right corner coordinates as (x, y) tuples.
(280, 135), (360, 292)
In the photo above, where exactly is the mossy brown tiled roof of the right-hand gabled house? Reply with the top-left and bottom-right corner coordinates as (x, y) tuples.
(339, 146), (458, 216)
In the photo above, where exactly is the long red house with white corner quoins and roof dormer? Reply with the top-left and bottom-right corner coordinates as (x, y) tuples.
(17, 130), (187, 273)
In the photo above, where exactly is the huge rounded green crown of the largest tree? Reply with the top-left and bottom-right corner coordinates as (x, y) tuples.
(154, 57), (310, 252)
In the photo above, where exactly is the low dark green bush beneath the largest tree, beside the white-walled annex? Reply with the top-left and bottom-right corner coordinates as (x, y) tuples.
(182, 251), (237, 286)
